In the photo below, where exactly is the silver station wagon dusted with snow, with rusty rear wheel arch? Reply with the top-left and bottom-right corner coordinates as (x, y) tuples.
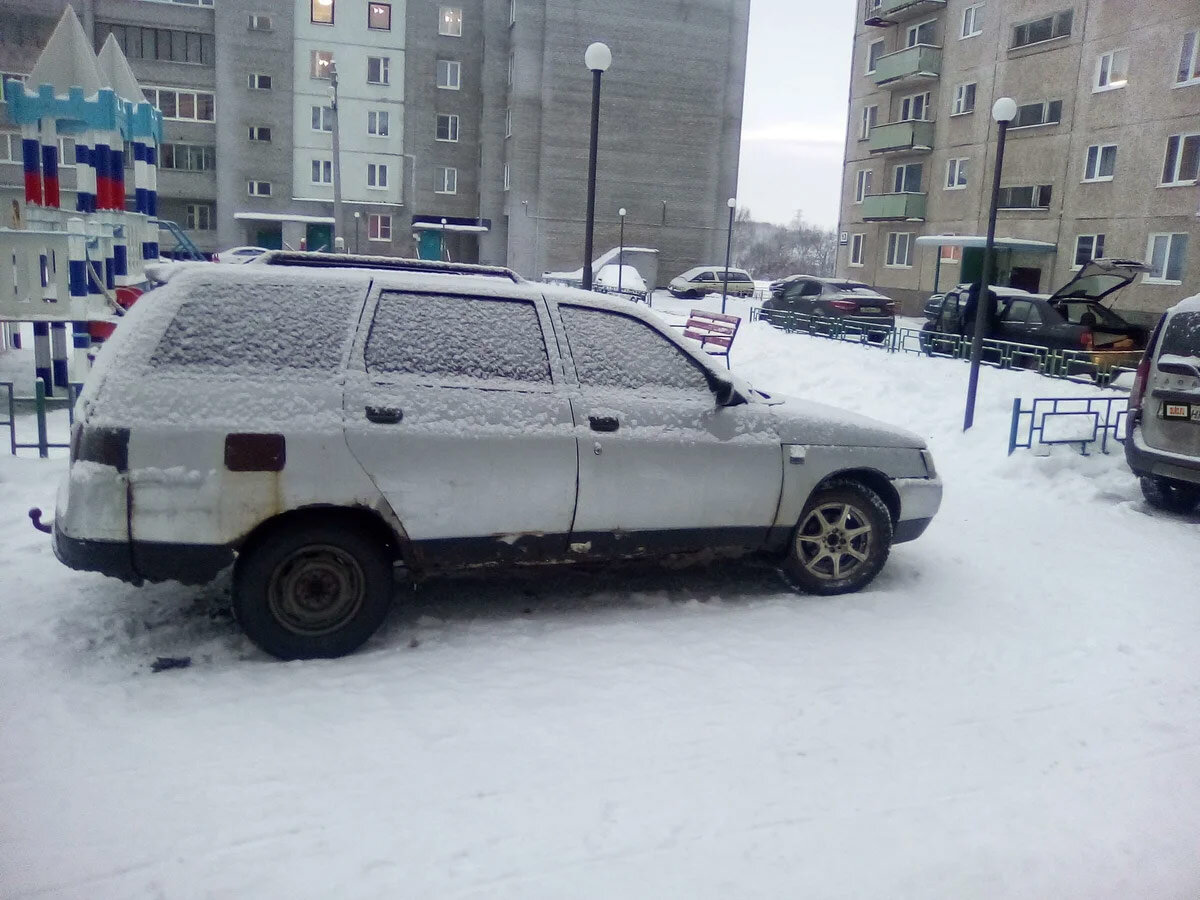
(46, 252), (942, 658)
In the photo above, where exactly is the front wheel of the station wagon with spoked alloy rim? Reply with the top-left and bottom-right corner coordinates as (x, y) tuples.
(782, 479), (892, 596)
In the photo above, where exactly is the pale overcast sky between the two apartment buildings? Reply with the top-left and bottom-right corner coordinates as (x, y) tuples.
(738, 0), (858, 228)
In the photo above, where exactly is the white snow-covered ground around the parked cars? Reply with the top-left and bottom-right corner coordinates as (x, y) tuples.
(0, 321), (1200, 900)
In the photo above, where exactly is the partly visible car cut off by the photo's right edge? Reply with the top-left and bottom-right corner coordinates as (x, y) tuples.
(1126, 295), (1200, 512)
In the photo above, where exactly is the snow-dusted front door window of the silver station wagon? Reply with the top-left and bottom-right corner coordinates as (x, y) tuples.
(559, 306), (709, 394)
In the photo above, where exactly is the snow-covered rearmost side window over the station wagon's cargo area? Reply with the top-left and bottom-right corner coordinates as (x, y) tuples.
(150, 280), (366, 372)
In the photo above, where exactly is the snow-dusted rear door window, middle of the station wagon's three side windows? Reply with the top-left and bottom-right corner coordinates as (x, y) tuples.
(365, 290), (550, 383)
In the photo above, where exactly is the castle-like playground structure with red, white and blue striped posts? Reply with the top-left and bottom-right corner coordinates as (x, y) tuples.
(0, 6), (162, 396)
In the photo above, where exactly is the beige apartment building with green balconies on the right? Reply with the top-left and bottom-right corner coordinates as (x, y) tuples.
(838, 0), (1200, 322)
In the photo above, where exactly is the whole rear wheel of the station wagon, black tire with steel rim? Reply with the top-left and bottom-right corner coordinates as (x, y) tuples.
(233, 520), (394, 660)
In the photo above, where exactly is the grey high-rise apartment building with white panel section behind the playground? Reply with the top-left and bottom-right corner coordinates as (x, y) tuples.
(0, 0), (750, 276)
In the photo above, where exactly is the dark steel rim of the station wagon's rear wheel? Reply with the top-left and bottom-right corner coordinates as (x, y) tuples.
(266, 544), (366, 637)
